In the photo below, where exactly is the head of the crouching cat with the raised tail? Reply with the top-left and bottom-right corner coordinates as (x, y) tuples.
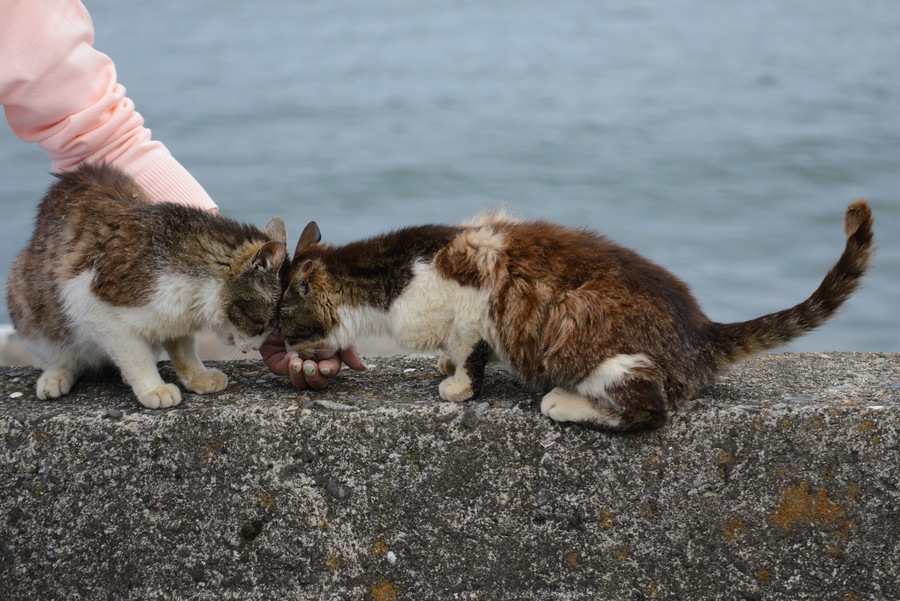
(277, 221), (338, 351)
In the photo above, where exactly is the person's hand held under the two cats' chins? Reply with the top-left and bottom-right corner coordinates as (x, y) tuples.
(259, 334), (366, 390)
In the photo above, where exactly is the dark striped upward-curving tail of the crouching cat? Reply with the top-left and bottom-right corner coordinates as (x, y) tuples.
(713, 200), (875, 368)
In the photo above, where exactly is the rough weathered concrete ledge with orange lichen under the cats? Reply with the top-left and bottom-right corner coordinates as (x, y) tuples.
(0, 353), (900, 601)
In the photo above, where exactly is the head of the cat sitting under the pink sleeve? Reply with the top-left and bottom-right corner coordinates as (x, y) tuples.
(220, 217), (287, 352)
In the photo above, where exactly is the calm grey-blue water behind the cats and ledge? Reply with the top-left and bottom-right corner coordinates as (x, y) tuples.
(0, 0), (900, 351)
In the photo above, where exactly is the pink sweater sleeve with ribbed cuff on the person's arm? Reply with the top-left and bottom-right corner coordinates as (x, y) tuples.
(0, 0), (216, 209)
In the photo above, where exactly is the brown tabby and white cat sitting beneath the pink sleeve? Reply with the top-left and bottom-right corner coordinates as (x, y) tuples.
(7, 165), (287, 408)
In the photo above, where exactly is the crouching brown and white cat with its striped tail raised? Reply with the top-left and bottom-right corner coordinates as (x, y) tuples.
(278, 201), (874, 431)
